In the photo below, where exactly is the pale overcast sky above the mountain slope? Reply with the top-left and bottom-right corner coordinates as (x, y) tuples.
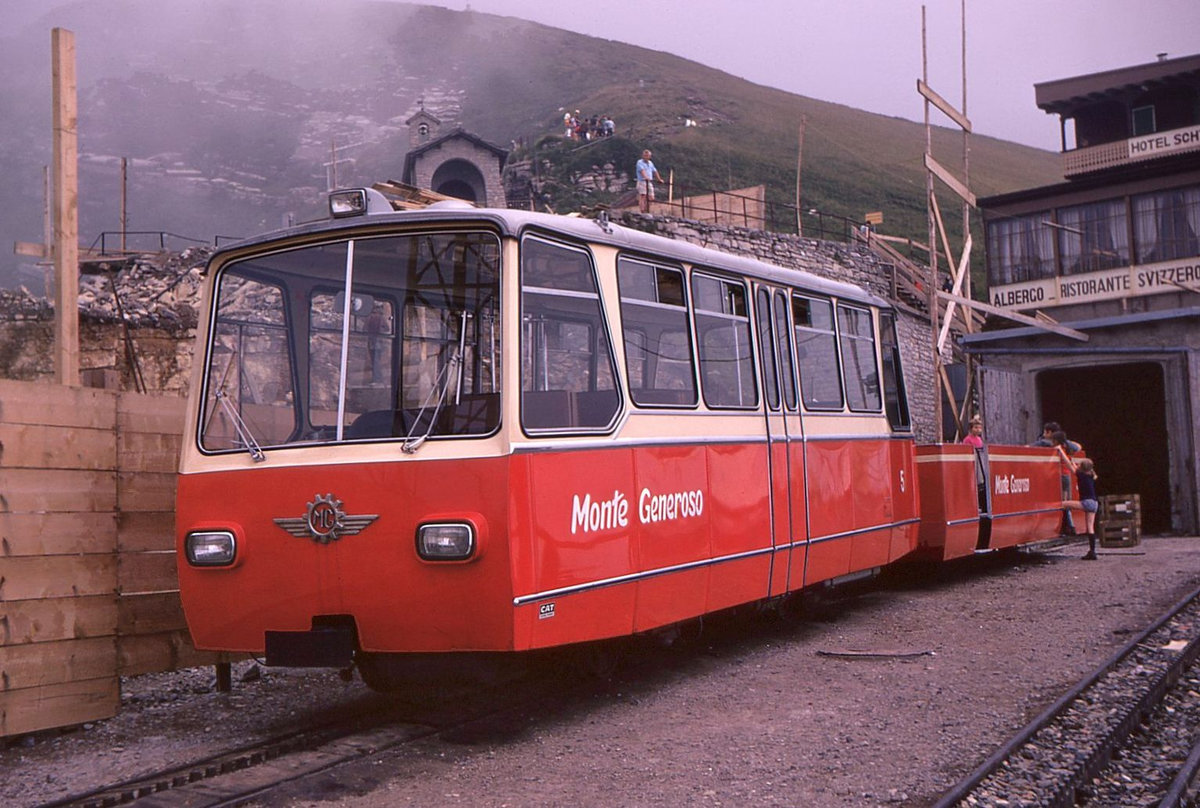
(416, 0), (1200, 151)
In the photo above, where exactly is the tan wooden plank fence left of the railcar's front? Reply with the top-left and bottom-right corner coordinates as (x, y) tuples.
(0, 381), (218, 737)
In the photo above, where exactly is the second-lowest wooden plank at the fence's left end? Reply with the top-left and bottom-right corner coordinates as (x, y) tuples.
(0, 636), (116, 693)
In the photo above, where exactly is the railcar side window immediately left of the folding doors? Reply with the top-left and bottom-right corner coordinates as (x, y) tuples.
(691, 273), (758, 408)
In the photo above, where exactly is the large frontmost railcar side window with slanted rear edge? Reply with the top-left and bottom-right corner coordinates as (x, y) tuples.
(521, 237), (620, 432)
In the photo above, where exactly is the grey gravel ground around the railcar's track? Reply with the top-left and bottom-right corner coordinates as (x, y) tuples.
(0, 538), (1200, 808)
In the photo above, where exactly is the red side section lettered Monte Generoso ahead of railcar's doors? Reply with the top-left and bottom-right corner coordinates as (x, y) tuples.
(511, 443), (770, 647)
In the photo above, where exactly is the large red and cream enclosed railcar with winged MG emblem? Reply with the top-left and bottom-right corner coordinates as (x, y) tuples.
(178, 190), (1056, 684)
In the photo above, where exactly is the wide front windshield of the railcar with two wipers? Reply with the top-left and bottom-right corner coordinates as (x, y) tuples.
(199, 232), (500, 456)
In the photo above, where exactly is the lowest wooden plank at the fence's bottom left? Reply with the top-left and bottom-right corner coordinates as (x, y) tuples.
(0, 676), (121, 736)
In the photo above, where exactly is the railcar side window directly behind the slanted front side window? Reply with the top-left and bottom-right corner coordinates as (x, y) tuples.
(617, 257), (697, 407)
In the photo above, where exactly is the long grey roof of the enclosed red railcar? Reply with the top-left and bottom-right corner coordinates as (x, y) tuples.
(212, 203), (892, 309)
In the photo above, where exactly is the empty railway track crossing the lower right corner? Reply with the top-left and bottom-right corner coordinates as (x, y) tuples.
(935, 588), (1200, 808)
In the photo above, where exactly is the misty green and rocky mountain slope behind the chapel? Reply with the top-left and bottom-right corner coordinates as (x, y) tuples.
(0, 0), (1057, 292)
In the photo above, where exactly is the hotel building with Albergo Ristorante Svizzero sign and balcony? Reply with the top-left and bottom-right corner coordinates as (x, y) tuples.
(964, 54), (1200, 534)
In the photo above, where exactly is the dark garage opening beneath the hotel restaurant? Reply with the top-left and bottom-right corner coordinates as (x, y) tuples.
(1037, 363), (1171, 533)
